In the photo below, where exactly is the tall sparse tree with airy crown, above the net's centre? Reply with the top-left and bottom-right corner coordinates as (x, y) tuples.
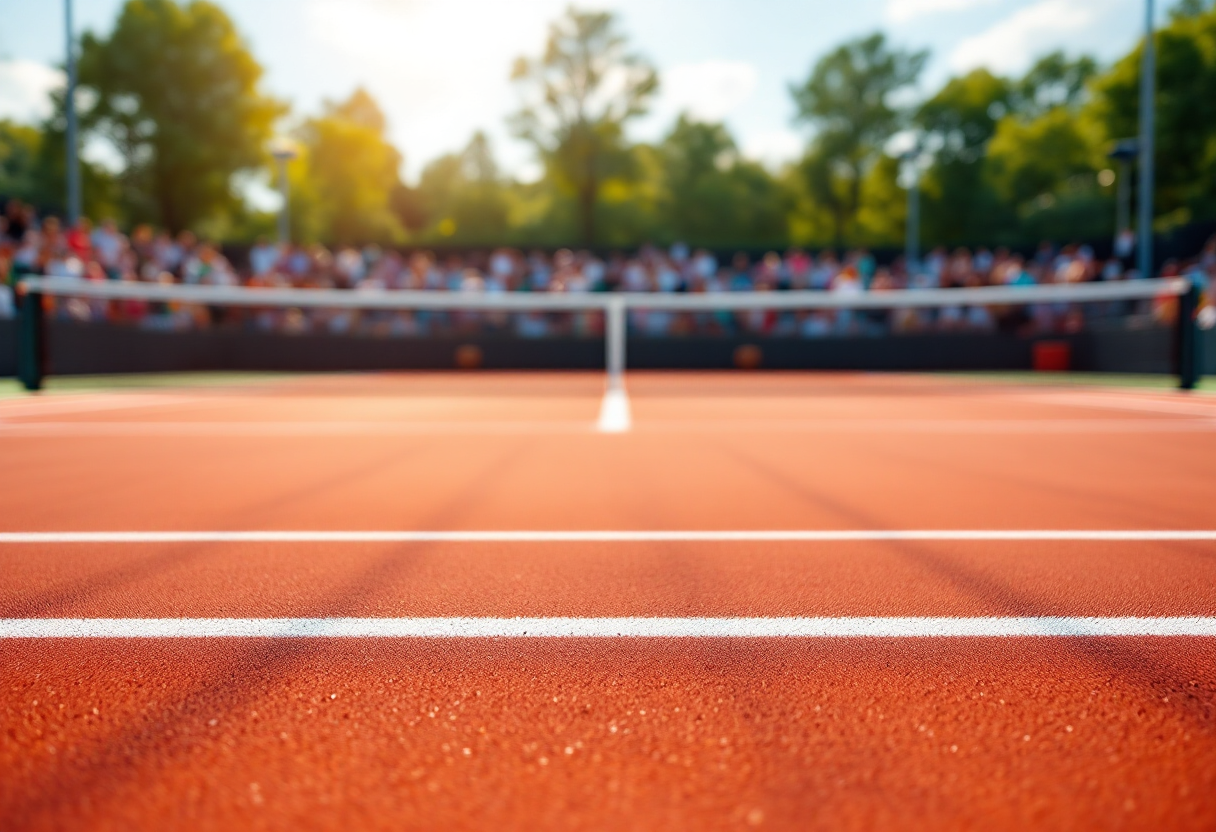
(511, 7), (658, 244)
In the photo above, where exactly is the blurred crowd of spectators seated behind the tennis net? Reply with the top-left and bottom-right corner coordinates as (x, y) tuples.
(0, 201), (1216, 337)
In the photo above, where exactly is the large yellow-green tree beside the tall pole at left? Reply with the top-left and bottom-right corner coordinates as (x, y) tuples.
(79, 0), (283, 230)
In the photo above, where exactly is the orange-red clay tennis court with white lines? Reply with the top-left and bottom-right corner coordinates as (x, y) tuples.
(0, 373), (1216, 830)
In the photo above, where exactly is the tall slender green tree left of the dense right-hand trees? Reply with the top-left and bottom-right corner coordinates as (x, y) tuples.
(790, 33), (929, 244)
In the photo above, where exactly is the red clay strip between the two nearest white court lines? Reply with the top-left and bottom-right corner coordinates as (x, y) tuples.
(0, 541), (1216, 620)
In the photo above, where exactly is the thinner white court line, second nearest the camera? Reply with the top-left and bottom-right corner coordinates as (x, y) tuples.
(0, 529), (1216, 544)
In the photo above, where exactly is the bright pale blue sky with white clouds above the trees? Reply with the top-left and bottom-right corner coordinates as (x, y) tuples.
(0, 0), (1171, 188)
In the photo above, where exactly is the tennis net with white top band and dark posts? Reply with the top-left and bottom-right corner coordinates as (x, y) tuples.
(7, 271), (1210, 389)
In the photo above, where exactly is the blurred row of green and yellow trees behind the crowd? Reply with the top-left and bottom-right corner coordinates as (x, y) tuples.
(19, 0), (1216, 248)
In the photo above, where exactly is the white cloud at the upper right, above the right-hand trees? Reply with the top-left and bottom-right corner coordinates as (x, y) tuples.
(950, 0), (1099, 73)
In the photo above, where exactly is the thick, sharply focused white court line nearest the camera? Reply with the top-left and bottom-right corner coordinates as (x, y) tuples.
(0, 617), (1216, 639)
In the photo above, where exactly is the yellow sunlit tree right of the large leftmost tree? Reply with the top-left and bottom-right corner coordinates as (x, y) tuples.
(293, 89), (405, 244)
